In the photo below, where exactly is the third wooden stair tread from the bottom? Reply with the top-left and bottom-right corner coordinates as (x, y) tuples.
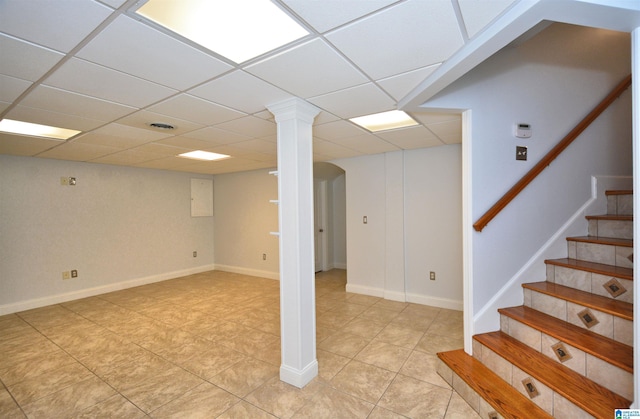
(498, 306), (633, 373)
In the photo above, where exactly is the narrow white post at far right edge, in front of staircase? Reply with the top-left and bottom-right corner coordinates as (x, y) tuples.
(631, 28), (640, 409)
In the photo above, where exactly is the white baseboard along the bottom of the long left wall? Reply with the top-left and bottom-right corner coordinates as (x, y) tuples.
(0, 265), (215, 316)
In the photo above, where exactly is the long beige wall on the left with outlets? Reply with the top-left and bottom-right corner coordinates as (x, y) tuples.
(0, 155), (214, 314)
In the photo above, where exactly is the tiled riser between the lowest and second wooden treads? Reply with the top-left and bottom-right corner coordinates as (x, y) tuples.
(472, 343), (591, 418)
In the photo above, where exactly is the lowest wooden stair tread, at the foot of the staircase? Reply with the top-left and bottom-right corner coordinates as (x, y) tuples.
(438, 349), (551, 419)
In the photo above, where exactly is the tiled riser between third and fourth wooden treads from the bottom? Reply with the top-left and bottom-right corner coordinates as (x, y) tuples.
(524, 289), (633, 346)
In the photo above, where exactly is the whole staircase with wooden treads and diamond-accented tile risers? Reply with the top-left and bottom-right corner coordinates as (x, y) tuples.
(438, 191), (633, 419)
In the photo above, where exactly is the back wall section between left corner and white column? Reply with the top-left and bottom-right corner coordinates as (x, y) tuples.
(213, 170), (280, 279)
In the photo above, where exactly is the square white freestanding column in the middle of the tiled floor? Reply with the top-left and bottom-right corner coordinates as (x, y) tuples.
(268, 98), (319, 388)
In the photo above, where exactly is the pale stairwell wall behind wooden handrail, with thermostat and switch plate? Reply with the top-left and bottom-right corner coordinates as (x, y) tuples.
(426, 24), (632, 333)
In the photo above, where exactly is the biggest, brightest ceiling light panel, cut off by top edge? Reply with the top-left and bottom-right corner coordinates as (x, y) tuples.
(136, 0), (309, 63)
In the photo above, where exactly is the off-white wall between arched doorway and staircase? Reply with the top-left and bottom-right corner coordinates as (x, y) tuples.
(334, 144), (462, 309)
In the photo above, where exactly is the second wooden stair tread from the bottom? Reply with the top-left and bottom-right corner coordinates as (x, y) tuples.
(474, 332), (631, 418)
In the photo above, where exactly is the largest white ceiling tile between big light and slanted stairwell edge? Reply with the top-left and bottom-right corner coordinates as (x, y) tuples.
(326, 0), (464, 80)
